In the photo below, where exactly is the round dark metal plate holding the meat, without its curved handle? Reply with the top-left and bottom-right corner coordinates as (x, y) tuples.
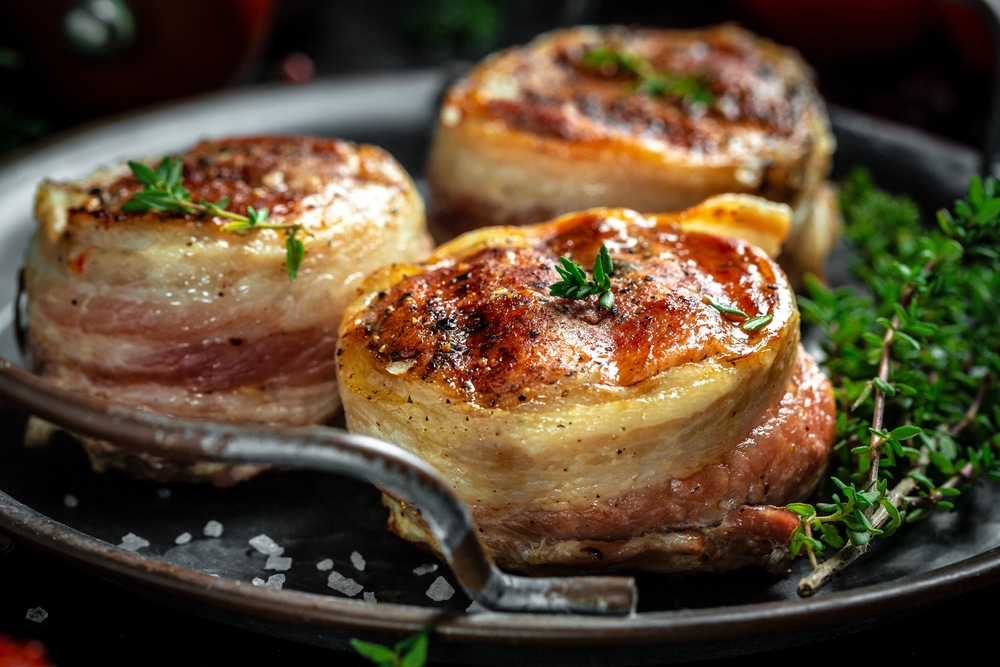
(0, 71), (1000, 665)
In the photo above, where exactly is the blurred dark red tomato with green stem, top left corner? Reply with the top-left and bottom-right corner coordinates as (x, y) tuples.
(0, 0), (274, 112)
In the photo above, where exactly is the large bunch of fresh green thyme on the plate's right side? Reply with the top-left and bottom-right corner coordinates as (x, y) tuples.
(789, 170), (1000, 596)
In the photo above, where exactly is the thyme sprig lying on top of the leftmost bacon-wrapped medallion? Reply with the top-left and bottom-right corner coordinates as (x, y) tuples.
(122, 156), (305, 280)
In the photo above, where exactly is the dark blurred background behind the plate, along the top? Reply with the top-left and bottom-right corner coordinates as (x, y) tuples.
(0, 0), (996, 159)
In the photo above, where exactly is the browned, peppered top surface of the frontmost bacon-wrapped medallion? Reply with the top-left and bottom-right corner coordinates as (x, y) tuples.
(345, 210), (797, 406)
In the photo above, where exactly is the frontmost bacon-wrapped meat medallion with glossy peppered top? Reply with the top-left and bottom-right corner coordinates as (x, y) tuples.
(339, 201), (833, 572)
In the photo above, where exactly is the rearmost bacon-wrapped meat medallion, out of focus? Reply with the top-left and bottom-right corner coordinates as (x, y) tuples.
(427, 24), (836, 280)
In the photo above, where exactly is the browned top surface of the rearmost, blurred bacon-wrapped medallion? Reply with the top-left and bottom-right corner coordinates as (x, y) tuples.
(447, 25), (825, 152)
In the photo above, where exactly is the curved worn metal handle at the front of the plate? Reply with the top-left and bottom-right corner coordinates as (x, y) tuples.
(0, 357), (637, 615)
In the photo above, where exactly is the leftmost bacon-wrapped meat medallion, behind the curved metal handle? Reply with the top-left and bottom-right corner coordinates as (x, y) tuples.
(24, 135), (431, 484)
